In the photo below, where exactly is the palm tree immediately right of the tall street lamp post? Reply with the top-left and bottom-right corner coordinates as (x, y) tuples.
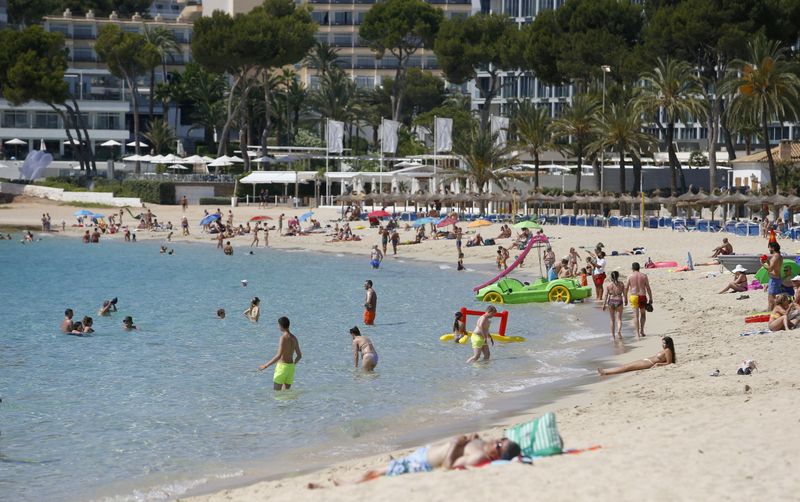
(590, 101), (657, 193)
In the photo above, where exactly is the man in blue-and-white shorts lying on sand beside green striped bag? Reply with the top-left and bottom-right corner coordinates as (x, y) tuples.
(336, 434), (520, 484)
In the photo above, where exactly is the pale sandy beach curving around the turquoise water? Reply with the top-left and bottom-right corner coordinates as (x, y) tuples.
(0, 198), (800, 502)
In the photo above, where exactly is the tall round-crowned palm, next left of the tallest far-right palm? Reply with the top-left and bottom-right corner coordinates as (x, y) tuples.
(637, 58), (706, 194)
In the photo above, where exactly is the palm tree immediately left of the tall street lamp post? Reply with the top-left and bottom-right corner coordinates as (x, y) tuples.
(551, 94), (600, 192)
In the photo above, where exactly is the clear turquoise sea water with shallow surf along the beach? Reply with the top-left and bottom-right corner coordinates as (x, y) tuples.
(0, 237), (607, 500)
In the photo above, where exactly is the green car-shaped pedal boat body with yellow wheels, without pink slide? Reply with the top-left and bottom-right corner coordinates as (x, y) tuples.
(475, 277), (592, 304)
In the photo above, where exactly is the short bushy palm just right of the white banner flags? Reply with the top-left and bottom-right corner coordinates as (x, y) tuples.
(447, 126), (517, 212)
